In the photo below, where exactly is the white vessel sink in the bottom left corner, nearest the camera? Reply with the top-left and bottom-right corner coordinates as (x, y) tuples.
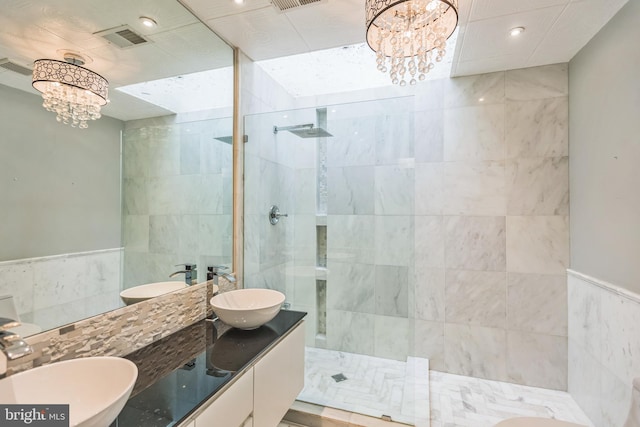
(0, 357), (138, 427)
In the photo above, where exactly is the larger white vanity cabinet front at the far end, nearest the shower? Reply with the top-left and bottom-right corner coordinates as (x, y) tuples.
(252, 323), (304, 427)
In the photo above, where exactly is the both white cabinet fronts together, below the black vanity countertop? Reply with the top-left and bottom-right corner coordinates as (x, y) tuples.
(180, 322), (304, 427)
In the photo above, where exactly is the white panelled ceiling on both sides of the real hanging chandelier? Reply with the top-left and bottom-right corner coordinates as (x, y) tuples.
(184, 0), (627, 76)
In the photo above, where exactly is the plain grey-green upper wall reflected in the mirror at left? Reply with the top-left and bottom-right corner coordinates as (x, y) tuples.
(0, 85), (123, 260)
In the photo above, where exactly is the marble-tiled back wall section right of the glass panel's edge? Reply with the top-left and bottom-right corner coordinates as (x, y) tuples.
(409, 64), (569, 390)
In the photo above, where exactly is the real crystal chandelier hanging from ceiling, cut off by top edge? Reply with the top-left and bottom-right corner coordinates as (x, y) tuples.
(365, 0), (458, 86)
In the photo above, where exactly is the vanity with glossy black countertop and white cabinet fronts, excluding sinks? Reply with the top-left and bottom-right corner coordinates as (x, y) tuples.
(112, 310), (306, 427)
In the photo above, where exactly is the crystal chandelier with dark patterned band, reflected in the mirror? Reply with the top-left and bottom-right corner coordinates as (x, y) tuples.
(32, 54), (109, 129)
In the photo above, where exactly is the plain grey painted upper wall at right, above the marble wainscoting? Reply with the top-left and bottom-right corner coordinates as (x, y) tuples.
(569, 0), (640, 292)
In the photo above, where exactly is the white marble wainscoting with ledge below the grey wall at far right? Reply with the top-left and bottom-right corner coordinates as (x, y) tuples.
(568, 270), (640, 427)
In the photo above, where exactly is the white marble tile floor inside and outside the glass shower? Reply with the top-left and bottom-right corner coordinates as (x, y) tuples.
(288, 348), (593, 427)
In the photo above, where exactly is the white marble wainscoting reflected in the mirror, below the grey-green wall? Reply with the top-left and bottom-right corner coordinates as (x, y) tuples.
(0, 248), (123, 330)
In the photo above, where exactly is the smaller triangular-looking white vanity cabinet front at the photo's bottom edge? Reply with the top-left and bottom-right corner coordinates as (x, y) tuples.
(195, 369), (253, 427)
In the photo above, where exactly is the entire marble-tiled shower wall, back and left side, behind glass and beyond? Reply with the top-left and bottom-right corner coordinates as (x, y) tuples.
(245, 64), (569, 389)
